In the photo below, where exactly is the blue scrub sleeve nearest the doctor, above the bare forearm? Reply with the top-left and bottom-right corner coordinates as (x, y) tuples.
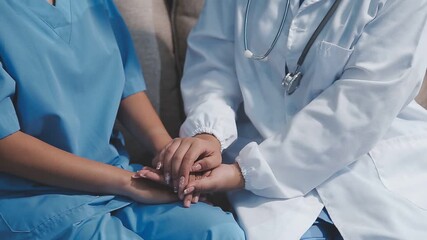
(105, 0), (146, 99)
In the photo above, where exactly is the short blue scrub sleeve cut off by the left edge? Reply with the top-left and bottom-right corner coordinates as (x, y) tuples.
(0, 62), (20, 139)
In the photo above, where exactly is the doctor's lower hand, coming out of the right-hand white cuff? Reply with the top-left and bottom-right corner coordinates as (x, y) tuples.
(184, 163), (245, 198)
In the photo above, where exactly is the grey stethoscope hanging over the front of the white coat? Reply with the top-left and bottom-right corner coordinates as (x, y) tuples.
(243, 0), (341, 95)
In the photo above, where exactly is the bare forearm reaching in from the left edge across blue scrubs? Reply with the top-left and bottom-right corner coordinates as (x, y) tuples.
(0, 132), (132, 195)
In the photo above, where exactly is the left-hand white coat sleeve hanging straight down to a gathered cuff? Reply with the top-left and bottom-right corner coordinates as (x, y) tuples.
(180, 0), (242, 148)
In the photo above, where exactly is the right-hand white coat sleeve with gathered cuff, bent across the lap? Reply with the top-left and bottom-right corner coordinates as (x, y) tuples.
(236, 0), (427, 198)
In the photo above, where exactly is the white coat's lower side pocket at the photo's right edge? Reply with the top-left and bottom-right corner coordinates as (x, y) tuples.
(369, 135), (427, 210)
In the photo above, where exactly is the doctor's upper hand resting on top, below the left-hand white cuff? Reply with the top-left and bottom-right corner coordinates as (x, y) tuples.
(153, 134), (222, 195)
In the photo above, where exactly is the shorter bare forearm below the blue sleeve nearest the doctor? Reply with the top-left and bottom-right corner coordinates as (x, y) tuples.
(118, 92), (171, 152)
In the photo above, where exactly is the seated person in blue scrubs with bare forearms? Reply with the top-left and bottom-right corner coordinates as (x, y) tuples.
(0, 0), (244, 239)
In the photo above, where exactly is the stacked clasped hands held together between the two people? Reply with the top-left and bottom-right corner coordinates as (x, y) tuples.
(134, 134), (244, 207)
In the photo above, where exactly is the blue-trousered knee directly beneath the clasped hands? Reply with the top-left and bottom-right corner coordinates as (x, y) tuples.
(113, 203), (245, 240)
